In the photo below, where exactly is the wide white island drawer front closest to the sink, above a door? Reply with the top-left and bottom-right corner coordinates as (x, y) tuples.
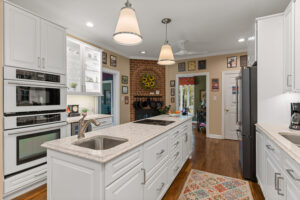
(105, 147), (143, 186)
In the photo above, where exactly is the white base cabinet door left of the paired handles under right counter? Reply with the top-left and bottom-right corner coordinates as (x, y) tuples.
(264, 153), (281, 200)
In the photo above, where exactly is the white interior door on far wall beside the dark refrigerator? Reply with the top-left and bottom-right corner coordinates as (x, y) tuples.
(223, 72), (239, 140)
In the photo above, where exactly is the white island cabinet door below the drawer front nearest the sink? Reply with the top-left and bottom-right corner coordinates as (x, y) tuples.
(105, 163), (144, 200)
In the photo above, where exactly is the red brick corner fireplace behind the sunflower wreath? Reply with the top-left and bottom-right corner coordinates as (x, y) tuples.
(130, 59), (166, 121)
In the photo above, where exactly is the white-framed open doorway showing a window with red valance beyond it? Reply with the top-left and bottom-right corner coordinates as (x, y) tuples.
(176, 72), (209, 135)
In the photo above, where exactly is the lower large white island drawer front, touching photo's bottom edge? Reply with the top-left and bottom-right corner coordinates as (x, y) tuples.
(144, 161), (169, 200)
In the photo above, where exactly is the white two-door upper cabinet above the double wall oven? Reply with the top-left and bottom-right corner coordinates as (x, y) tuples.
(4, 3), (66, 74)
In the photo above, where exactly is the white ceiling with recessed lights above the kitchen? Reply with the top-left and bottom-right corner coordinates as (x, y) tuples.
(10, 0), (290, 59)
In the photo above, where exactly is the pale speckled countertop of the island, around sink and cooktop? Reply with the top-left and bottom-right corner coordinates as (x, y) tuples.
(42, 115), (192, 163)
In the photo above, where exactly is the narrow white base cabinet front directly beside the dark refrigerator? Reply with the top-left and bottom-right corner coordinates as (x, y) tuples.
(256, 132), (265, 187)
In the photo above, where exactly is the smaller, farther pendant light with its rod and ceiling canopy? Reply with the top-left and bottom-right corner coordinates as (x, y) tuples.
(157, 18), (175, 65)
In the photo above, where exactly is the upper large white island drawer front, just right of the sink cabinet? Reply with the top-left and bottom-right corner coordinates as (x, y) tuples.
(144, 134), (169, 179)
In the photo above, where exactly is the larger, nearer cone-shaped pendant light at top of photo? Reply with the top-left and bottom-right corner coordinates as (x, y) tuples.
(113, 0), (143, 46)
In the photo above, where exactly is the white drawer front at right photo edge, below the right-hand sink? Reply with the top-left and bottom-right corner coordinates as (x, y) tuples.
(284, 156), (300, 191)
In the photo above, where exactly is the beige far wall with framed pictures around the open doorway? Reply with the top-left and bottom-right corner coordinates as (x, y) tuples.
(166, 53), (247, 135)
